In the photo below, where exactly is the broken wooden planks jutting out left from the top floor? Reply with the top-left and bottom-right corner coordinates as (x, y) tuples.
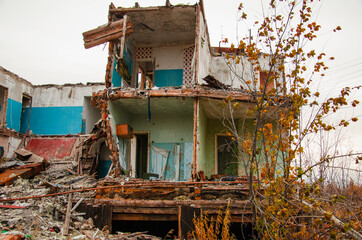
(83, 18), (133, 49)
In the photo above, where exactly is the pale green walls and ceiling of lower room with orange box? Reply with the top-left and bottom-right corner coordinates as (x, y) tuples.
(109, 98), (193, 180)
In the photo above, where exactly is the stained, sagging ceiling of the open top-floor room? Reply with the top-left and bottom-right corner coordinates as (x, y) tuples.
(119, 6), (196, 47)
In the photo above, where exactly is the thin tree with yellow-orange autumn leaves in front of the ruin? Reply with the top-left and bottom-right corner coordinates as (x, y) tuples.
(218, 0), (362, 239)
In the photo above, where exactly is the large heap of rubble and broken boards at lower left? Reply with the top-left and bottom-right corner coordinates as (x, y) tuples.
(0, 169), (159, 239)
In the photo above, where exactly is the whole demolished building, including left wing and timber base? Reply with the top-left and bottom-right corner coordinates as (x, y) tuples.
(0, 1), (284, 239)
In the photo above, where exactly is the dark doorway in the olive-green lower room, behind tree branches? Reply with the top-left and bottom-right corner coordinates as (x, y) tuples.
(216, 135), (238, 176)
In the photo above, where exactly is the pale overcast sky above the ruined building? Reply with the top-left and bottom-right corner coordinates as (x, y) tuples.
(0, 0), (362, 154)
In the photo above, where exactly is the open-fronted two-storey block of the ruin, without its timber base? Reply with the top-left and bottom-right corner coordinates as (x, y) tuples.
(83, 1), (281, 181)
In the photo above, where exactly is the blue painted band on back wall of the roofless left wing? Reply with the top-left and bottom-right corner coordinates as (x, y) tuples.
(29, 106), (83, 135)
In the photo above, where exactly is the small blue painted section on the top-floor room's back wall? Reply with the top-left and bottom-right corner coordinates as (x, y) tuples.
(155, 69), (183, 87)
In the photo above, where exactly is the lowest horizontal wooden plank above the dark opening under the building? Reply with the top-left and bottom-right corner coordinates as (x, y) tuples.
(112, 213), (177, 221)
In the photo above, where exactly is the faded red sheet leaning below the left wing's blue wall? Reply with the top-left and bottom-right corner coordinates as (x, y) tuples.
(25, 137), (77, 161)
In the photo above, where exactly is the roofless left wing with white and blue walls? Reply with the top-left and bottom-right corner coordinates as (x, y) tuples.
(0, 67), (104, 158)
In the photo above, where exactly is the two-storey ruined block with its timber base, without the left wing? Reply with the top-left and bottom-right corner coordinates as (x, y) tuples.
(79, 1), (285, 238)
